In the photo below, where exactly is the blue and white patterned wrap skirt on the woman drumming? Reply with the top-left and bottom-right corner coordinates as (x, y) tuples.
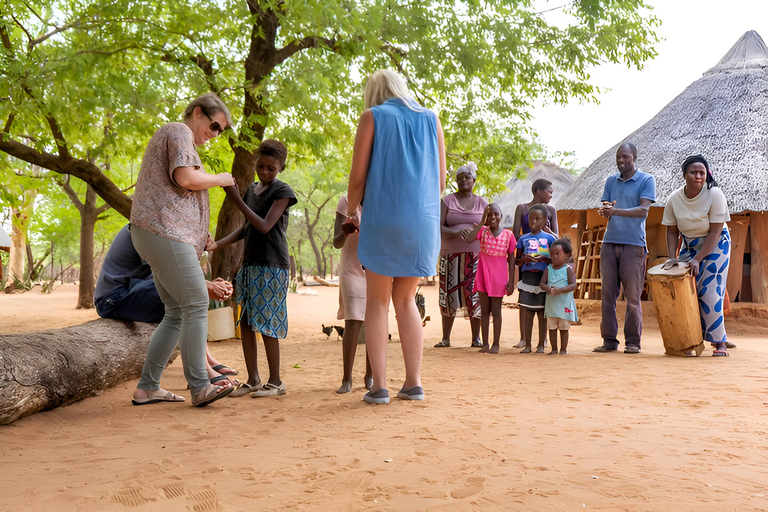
(680, 227), (731, 343)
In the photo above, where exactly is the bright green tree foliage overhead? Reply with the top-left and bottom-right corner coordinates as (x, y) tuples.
(0, 0), (658, 276)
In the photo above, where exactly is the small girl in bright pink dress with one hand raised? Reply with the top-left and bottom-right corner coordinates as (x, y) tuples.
(465, 203), (515, 354)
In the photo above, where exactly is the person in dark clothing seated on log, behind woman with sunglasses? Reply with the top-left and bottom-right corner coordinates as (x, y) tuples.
(93, 224), (237, 384)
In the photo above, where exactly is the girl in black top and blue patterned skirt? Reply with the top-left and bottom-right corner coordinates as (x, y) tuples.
(207, 140), (297, 398)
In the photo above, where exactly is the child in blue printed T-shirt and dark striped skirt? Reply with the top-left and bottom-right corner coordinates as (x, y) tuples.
(515, 204), (555, 354)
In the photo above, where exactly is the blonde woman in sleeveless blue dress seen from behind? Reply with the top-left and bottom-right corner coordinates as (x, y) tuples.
(345, 70), (445, 404)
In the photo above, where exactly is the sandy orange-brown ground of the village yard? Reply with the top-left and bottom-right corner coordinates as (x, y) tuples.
(0, 285), (768, 511)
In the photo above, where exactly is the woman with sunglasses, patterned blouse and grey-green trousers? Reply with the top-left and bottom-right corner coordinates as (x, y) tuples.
(130, 93), (235, 407)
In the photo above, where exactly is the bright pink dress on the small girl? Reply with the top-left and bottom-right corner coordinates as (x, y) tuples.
(475, 226), (517, 297)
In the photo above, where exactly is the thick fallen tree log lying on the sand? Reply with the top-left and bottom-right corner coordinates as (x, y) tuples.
(0, 319), (178, 425)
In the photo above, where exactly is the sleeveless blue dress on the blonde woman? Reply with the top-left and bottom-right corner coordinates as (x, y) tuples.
(357, 98), (440, 277)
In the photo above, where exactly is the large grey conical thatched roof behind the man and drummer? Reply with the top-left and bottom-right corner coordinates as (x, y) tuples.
(559, 31), (768, 213)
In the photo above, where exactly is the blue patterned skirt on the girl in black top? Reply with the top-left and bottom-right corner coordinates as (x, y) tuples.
(235, 265), (288, 339)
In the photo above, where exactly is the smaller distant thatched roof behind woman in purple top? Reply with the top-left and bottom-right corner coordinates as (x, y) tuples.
(495, 160), (576, 227)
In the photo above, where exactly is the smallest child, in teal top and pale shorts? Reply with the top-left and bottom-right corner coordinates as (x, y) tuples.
(539, 238), (579, 355)
